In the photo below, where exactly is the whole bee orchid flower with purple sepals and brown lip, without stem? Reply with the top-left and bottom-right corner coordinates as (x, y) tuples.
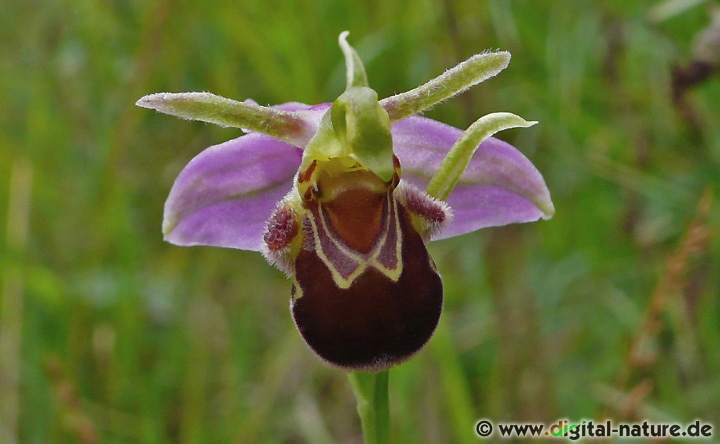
(137, 32), (554, 371)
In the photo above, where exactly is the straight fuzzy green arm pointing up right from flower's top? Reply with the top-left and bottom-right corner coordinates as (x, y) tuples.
(380, 51), (510, 122)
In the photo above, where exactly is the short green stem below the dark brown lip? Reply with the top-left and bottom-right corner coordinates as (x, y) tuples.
(348, 370), (390, 444)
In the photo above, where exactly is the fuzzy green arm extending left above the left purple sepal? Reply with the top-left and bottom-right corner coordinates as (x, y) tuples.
(135, 92), (312, 146)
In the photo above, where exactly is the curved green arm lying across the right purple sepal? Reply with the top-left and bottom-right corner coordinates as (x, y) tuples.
(425, 113), (537, 200)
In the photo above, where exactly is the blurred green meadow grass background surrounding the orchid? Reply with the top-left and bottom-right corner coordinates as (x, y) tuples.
(0, 0), (720, 443)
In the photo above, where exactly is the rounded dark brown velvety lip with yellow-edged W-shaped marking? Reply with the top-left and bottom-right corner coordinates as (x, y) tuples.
(291, 190), (443, 371)
